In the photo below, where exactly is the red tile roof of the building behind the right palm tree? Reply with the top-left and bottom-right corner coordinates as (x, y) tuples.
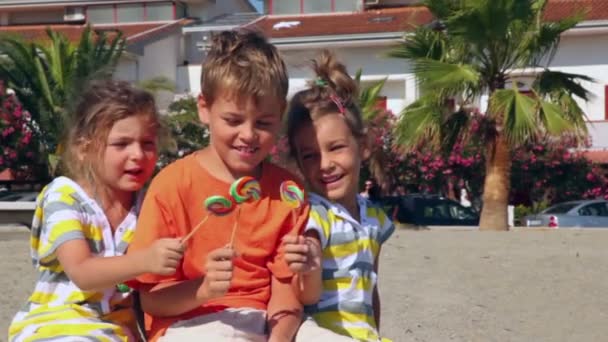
(249, 0), (608, 38)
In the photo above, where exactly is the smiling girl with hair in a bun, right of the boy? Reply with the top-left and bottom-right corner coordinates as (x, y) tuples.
(283, 51), (394, 341)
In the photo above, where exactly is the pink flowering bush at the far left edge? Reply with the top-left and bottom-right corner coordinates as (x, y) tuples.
(0, 81), (38, 178)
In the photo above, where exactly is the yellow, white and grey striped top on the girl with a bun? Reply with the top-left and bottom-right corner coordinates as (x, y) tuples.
(305, 194), (395, 341)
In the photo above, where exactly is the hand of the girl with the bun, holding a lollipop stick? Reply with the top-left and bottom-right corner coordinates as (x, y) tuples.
(283, 235), (321, 273)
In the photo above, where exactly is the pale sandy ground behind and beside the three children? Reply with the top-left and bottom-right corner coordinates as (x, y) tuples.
(0, 229), (608, 341)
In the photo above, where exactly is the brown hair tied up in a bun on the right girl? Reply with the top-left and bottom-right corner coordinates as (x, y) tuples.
(287, 50), (366, 157)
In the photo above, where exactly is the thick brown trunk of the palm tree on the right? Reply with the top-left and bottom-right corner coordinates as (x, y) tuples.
(479, 133), (511, 230)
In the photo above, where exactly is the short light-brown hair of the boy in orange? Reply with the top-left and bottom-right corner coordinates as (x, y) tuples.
(201, 29), (289, 107)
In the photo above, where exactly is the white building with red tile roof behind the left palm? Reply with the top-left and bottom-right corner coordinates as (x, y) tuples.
(0, 0), (259, 106)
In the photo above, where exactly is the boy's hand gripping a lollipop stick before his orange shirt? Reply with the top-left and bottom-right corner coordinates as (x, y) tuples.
(200, 246), (236, 299)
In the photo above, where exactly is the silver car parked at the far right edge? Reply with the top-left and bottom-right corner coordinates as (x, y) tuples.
(524, 199), (608, 228)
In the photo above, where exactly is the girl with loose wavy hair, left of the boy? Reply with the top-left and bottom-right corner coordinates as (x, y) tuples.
(9, 81), (182, 341)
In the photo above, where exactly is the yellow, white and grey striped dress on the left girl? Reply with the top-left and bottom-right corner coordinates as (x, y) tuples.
(9, 177), (136, 342)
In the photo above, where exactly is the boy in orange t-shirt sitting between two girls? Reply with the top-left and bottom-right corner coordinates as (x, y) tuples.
(129, 31), (309, 341)
